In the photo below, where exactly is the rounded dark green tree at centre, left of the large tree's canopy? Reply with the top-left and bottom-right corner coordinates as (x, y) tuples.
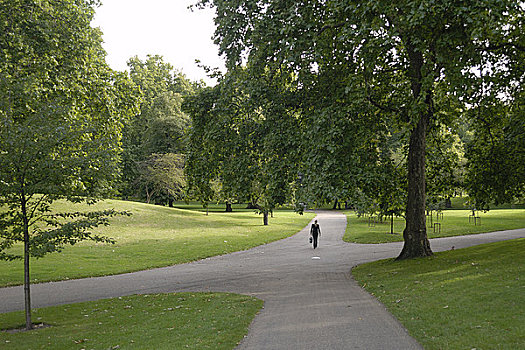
(185, 69), (295, 225)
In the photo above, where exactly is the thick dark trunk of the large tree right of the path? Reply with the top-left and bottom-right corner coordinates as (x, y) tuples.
(397, 109), (432, 260)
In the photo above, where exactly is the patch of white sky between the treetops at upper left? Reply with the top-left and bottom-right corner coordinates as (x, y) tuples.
(92, 0), (224, 85)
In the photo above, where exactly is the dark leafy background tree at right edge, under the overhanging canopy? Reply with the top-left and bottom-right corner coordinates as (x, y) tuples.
(465, 90), (525, 210)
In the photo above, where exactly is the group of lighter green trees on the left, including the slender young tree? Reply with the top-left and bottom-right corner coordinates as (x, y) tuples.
(0, 0), (200, 329)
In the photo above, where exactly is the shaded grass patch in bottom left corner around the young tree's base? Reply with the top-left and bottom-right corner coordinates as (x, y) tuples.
(0, 293), (263, 350)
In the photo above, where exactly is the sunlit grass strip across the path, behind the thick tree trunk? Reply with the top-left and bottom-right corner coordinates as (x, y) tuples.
(343, 209), (525, 243)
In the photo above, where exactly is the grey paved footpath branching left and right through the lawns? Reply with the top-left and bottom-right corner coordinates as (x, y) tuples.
(0, 212), (525, 350)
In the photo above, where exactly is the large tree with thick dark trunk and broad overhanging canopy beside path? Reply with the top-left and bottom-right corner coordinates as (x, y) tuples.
(200, 0), (524, 259)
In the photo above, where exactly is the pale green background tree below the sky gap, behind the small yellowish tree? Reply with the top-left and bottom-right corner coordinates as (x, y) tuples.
(122, 56), (200, 203)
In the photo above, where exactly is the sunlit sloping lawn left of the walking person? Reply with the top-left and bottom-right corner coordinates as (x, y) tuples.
(0, 200), (314, 286)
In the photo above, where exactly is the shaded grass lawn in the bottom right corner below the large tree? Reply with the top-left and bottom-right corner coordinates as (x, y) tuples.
(352, 239), (525, 350)
